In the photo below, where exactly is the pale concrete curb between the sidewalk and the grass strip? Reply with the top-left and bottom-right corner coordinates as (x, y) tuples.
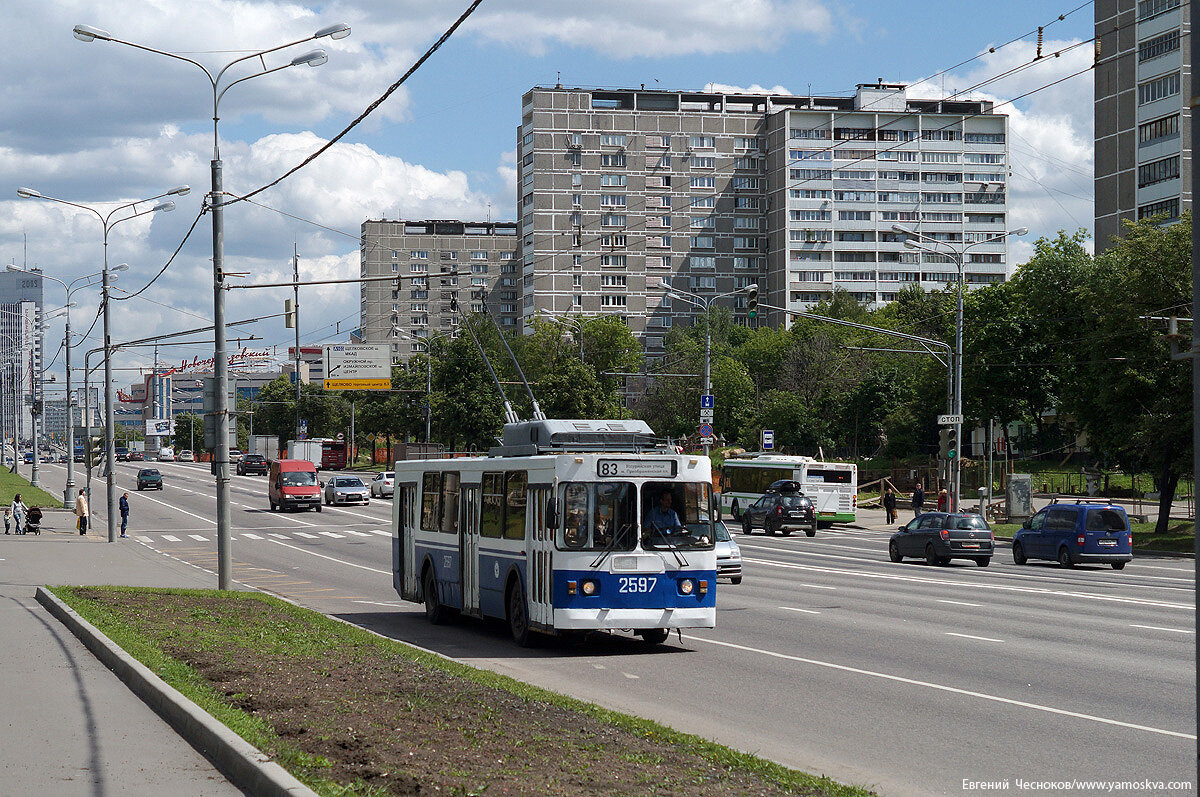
(36, 587), (317, 797)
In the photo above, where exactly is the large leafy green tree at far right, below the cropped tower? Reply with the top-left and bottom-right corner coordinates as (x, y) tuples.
(1064, 212), (1193, 533)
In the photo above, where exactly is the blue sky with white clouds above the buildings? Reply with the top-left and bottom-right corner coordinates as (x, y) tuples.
(0, 0), (1093, 379)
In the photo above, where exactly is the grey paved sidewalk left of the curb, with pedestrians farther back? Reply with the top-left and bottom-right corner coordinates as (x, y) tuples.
(0, 519), (242, 797)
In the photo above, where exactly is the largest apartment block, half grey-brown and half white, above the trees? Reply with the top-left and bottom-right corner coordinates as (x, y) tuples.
(517, 83), (1008, 353)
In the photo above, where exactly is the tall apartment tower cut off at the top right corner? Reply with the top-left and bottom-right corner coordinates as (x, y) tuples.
(1096, 0), (1192, 250)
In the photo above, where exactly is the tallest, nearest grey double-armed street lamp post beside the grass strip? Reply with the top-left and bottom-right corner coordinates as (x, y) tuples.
(72, 24), (350, 589)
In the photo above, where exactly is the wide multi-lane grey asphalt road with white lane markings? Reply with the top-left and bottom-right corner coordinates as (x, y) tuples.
(28, 463), (1196, 795)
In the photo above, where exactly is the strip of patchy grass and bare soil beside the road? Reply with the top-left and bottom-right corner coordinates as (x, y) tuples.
(53, 587), (871, 797)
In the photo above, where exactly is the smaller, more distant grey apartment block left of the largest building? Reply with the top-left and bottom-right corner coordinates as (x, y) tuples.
(359, 214), (521, 362)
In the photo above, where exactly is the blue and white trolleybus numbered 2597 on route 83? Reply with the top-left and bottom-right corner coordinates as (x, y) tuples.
(392, 420), (716, 646)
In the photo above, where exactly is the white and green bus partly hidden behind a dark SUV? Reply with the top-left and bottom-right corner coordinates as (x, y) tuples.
(721, 454), (858, 526)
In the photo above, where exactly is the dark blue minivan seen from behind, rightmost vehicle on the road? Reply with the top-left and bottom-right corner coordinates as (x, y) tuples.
(1013, 499), (1133, 570)
